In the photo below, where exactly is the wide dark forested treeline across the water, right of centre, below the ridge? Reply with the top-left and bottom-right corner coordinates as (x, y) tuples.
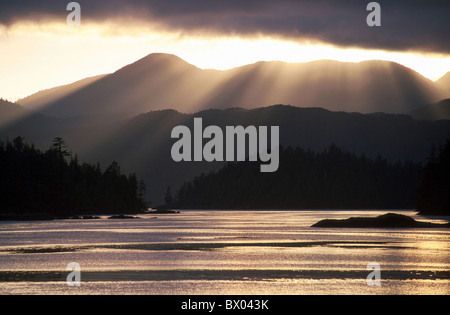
(173, 145), (422, 209)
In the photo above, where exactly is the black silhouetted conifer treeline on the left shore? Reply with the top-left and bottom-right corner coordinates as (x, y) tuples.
(0, 137), (145, 217)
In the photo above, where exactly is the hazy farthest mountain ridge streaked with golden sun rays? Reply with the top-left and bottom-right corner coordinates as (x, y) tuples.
(18, 54), (443, 117)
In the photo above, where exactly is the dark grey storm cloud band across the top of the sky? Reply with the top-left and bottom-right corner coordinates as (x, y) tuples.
(0, 0), (450, 53)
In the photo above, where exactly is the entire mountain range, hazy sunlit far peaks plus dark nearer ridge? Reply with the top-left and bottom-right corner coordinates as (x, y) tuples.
(0, 54), (450, 205)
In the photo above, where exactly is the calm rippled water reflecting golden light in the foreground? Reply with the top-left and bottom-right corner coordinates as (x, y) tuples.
(0, 211), (450, 295)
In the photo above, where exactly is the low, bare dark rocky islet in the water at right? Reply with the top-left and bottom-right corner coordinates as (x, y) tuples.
(312, 213), (450, 228)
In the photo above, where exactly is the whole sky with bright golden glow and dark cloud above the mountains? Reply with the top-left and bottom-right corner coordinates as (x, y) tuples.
(0, 0), (450, 101)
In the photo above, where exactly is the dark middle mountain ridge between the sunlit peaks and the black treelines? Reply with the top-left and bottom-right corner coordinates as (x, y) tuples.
(0, 105), (450, 204)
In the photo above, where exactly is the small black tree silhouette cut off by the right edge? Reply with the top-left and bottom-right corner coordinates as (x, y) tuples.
(417, 139), (450, 215)
